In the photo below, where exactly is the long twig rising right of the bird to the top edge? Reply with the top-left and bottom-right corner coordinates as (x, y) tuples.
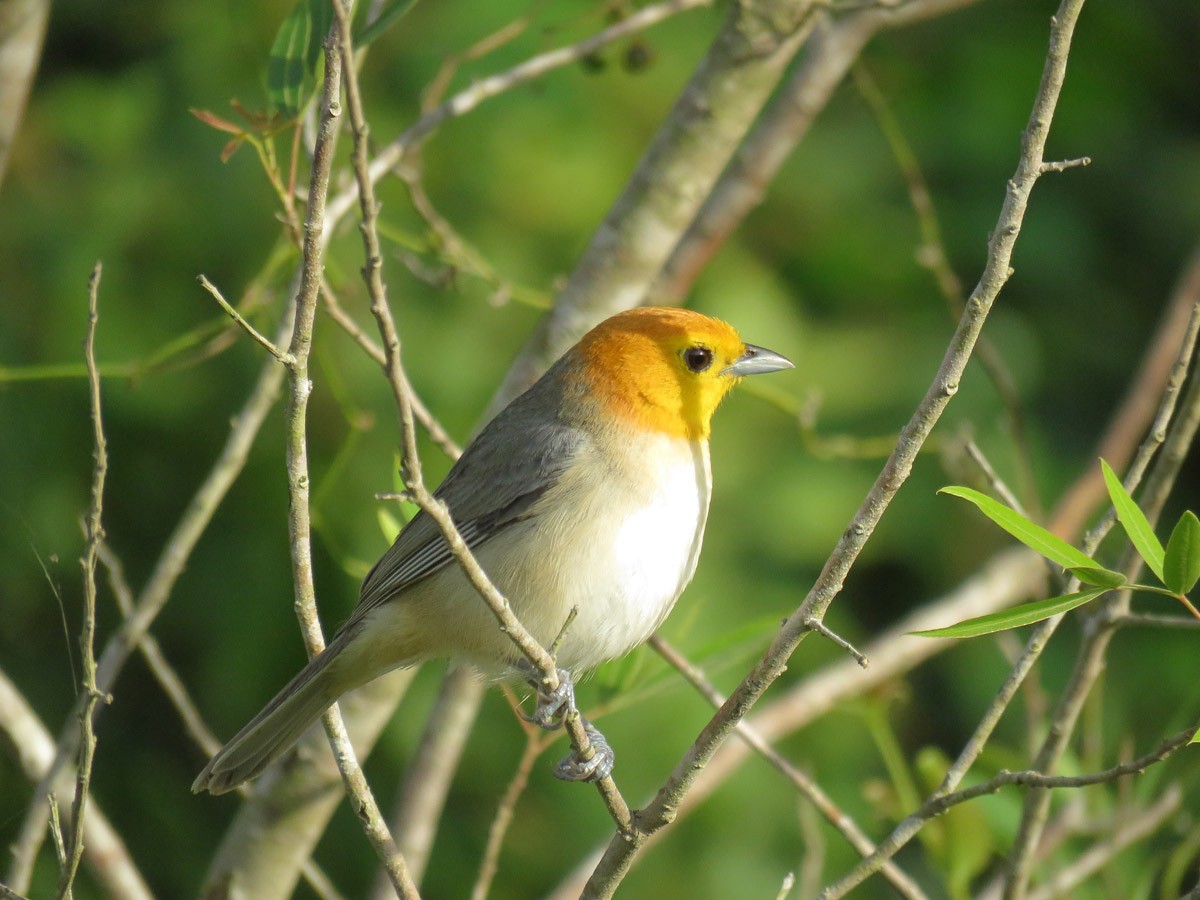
(584, 0), (1080, 898)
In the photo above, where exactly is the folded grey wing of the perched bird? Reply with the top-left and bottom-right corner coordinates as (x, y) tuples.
(354, 391), (589, 618)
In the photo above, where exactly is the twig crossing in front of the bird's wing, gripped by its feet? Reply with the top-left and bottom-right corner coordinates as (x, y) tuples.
(338, 0), (631, 830)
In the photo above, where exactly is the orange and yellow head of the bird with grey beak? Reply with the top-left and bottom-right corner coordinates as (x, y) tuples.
(576, 307), (792, 440)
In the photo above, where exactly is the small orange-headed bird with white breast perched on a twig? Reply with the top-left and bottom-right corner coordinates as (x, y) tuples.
(192, 307), (793, 793)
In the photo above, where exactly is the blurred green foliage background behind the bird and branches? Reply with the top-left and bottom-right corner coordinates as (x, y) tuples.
(0, 0), (1200, 898)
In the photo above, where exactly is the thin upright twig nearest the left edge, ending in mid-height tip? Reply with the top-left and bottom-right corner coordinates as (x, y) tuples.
(58, 263), (109, 898)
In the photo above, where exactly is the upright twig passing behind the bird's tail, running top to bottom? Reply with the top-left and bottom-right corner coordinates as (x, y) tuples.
(279, 8), (419, 898)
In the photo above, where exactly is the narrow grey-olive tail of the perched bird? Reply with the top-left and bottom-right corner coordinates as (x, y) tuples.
(192, 632), (361, 793)
